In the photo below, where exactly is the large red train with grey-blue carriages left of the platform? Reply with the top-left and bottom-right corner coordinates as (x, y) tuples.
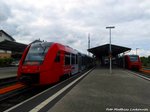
(17, 42), (93, 85)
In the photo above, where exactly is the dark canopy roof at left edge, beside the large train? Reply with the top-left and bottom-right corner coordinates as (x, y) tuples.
(0, 40), (27, 52)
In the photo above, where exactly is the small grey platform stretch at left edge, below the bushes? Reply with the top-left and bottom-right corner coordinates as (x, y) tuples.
(0, 67), (17, 79)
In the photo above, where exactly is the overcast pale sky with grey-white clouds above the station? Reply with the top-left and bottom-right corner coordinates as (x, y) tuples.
(0, 0), (150, 56)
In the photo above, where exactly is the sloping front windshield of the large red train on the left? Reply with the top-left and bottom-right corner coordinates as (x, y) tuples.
(24, 43), (49, 65)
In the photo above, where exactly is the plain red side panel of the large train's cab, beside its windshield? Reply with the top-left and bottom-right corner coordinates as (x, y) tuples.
(40, 45), (62, 85)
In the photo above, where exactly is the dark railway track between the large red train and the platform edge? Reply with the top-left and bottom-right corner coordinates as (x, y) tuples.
(0, 68), (92, 112)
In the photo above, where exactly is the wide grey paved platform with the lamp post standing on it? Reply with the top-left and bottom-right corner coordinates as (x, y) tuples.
(4, 67), (150, 112)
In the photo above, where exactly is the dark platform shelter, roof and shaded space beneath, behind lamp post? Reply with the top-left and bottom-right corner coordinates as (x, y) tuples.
(88, 44), (131, 66)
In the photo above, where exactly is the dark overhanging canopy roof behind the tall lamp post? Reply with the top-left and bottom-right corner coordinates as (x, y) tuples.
(88, 44), (131, 57)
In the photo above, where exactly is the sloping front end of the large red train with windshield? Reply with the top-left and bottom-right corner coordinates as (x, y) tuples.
(18, 42), (49, 85)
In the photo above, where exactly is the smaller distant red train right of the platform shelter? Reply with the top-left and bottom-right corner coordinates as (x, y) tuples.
(117, 55), (142, 70)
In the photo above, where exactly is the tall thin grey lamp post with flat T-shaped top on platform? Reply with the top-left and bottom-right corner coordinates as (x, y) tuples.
(106, 26), (115, 74)
